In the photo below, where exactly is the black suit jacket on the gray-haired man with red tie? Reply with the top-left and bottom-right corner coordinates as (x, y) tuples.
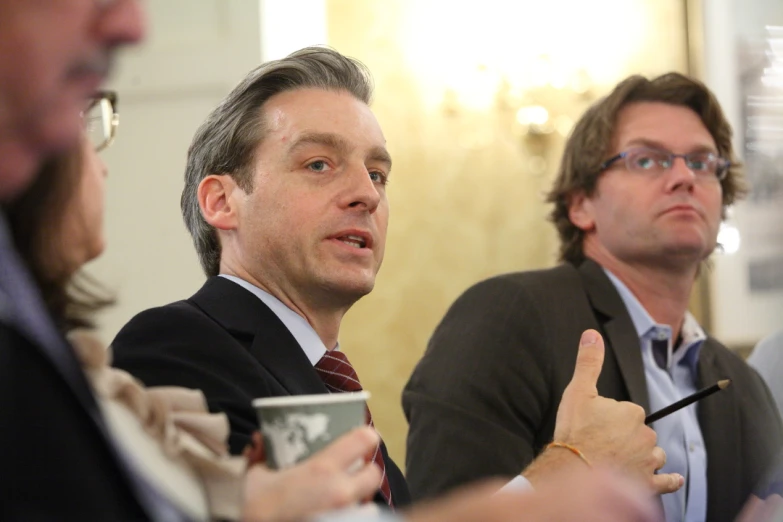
(112, 277), (410, 506)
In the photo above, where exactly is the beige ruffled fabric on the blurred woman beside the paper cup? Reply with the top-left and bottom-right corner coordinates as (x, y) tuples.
(68, 331), (247, 519)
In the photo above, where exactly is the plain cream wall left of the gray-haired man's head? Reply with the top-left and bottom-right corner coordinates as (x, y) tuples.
(94, 0), (261, 343)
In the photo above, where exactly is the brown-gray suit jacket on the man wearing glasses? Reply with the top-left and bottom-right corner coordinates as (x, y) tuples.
(403, 261), (783, 522)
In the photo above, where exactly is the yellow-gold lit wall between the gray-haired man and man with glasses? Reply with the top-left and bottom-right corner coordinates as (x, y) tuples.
(327, 0), (686, 464)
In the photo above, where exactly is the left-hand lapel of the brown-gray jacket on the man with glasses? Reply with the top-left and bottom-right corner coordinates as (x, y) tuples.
(579, 259), (650, 414)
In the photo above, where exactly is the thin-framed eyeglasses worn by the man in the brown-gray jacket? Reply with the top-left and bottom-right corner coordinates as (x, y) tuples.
(599, 147), (731, 180)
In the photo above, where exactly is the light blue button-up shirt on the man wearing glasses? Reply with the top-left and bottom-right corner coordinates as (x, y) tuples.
(604, 269), (707, 522)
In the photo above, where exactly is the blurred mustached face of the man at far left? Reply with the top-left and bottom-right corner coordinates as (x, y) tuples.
(0, 0), (144, 201)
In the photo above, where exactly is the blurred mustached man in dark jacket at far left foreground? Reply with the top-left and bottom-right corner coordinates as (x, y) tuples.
(0, 0), (168, 520)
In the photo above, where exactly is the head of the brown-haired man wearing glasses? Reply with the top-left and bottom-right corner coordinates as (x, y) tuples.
(548, 73), (745, 264)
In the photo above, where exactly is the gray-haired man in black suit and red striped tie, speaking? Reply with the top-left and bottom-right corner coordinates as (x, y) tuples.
(113, 44), (682, 519)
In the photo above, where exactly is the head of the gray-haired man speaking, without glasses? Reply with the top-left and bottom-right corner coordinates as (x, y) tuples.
(182, 48), (391, 306)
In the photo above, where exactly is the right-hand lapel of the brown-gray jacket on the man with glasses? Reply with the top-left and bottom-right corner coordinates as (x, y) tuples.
(697, 337), (745, 520)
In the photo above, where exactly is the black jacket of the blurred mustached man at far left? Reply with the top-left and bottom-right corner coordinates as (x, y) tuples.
(0, 316), (148, 521)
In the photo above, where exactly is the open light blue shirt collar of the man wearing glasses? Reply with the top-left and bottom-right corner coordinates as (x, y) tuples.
(602, 267), (707, 378)
